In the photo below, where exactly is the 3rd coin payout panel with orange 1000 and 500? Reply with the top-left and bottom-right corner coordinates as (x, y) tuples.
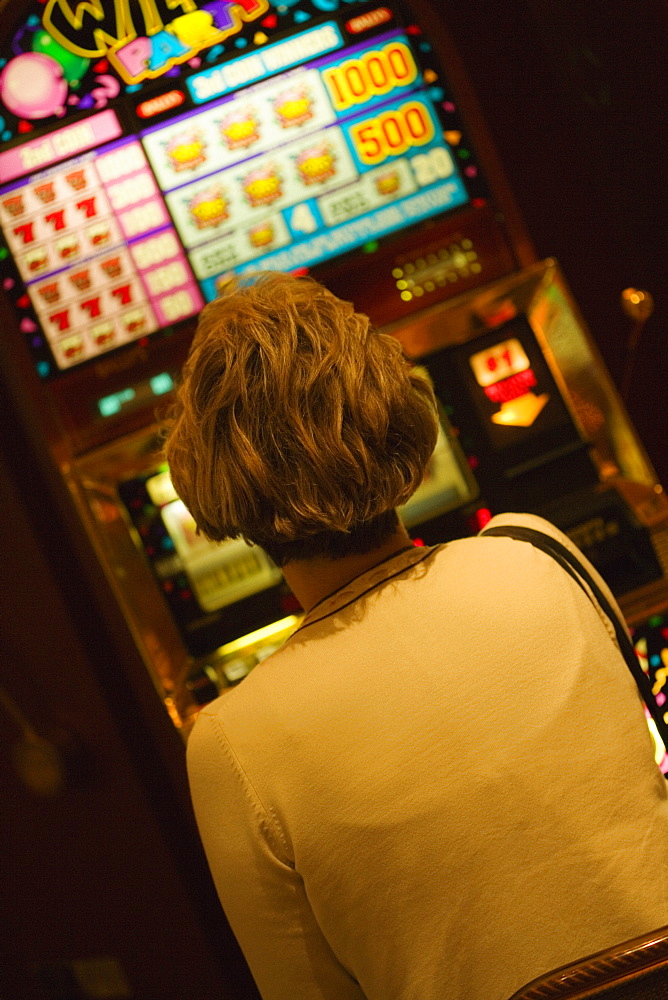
(141, 29), (467, 300)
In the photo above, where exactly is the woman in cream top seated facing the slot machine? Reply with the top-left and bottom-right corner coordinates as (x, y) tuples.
(166, 274), (668, 1000)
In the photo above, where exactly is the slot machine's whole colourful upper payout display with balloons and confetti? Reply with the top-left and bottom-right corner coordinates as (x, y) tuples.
(0, 0), (504, 378)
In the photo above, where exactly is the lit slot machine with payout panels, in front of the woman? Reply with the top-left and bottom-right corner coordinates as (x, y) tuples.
(0, 0), (668, 768)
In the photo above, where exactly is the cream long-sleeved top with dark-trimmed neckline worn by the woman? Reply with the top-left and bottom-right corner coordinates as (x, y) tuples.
(188, 514), (668, 1000)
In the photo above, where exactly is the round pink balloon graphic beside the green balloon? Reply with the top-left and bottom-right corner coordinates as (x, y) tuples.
(0, 52), (67, 118)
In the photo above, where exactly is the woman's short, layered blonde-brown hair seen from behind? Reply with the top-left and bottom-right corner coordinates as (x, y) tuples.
(165, 272), (437, 563)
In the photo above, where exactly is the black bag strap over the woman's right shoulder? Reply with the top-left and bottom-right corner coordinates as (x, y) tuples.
(481, 525), (668, 747)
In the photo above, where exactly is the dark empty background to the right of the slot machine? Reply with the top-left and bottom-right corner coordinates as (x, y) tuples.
(435, 0), (668, 485)
